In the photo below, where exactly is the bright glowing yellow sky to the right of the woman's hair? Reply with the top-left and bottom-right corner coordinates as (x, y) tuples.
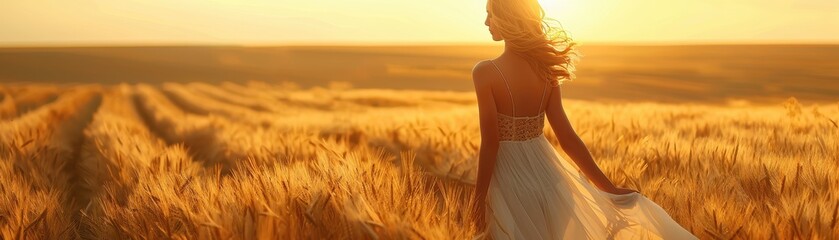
(539, 0), (839, 43)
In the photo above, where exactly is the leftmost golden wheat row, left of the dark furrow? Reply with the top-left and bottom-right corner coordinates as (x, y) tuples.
(0, 89), (100, 239)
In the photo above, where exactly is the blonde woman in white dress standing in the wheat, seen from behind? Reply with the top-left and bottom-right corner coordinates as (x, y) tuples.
(472, 0), (696, 240)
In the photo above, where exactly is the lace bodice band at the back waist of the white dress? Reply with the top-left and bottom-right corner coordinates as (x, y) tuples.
(498, 112), (545, 141)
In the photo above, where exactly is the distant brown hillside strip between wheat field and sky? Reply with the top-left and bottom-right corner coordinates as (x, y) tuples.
(0, 45), (839, 103)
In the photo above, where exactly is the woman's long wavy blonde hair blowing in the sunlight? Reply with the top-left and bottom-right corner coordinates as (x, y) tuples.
(488, 0), (579, 86)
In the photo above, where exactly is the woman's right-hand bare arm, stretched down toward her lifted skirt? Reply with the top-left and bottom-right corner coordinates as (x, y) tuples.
(546, 87), (634, 194)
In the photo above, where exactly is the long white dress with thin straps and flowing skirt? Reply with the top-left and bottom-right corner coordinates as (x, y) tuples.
(486, 62), (697, 240)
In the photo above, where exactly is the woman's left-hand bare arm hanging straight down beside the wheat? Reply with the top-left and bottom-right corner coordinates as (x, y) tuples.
(472, 62), (499, 228)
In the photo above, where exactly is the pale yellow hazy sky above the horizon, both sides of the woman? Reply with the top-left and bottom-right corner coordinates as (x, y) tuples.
(0, 0), (839, 46)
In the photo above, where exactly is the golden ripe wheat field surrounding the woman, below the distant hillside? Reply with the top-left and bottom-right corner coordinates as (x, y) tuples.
(0, 81), (839, 239)
